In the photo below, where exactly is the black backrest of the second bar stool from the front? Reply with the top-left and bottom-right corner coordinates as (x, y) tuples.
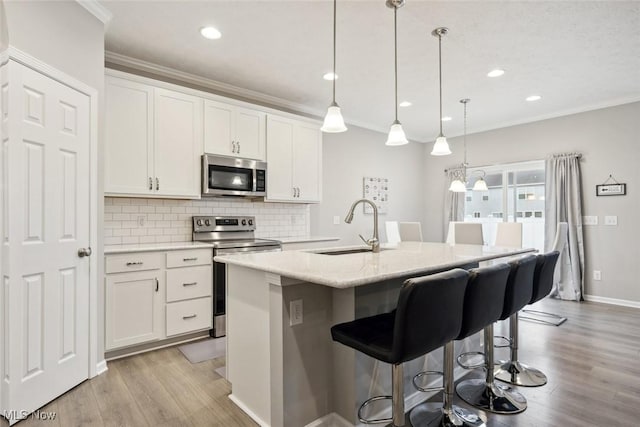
(456, 263), (511, 340)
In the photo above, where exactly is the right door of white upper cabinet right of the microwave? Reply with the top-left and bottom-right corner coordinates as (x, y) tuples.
(293, 123), (322, 202)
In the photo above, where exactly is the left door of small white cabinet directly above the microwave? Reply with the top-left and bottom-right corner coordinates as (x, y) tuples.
(204, 100), (236, 156)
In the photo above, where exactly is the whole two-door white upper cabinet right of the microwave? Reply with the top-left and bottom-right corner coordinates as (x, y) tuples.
(266, 115), (322, 203)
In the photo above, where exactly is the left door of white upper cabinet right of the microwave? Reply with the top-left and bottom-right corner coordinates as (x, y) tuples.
(266, 115), (296, 201)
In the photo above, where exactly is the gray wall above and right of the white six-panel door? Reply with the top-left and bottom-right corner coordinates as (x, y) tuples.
(4, 0), (104, 358)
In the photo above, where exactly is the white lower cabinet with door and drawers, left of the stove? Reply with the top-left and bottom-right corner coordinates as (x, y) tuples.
(105, 249), (213, 351)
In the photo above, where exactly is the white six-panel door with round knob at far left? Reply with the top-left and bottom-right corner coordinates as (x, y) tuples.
(5, 62), (90, 422)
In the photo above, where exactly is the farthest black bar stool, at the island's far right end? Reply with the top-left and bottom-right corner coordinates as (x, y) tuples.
(495, 251), (560, 387)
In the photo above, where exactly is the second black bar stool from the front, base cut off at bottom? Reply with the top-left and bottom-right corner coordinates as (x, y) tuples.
(410, 264), (511, 427)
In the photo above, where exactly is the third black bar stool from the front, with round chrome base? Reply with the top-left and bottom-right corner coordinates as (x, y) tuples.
(456, 255), (536, 414)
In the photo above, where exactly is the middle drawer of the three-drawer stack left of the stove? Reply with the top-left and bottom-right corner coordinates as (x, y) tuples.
(167, 265), (213, 302)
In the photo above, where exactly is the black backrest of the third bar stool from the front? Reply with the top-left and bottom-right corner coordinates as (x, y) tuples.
(500, 255), (537, 320)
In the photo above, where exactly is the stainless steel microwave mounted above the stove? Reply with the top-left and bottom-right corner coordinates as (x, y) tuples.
(202, 154), (267, 197)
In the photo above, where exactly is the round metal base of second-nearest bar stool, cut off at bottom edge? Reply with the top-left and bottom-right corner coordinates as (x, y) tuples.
(409, 403), (487, 427)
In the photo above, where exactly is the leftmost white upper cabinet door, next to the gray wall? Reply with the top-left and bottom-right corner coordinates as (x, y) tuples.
(104, 76), (153, 195)
